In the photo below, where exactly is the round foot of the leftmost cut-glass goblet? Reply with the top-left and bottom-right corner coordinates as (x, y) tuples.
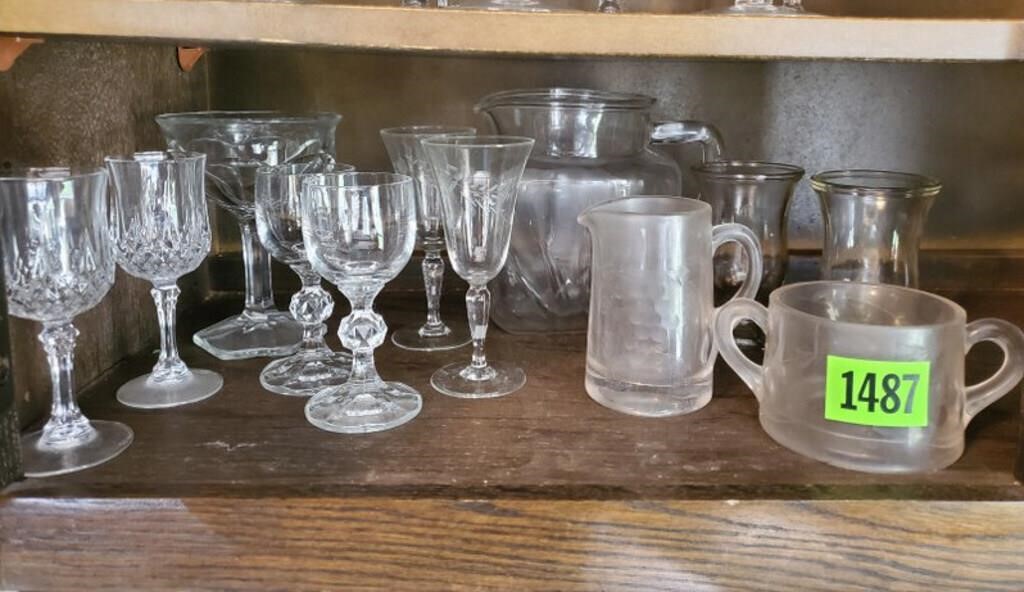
(22, 421), (135, 477)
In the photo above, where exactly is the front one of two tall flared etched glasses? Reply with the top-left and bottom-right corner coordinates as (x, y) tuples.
(423, 135), (534, 398)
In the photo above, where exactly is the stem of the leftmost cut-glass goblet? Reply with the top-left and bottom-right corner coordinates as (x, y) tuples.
(39, 322), (95, 448)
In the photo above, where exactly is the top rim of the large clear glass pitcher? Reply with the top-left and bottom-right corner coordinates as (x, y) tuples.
(473, 86), (656, 113)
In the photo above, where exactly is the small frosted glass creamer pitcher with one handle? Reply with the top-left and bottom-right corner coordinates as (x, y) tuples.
(579, 197), (762, 417)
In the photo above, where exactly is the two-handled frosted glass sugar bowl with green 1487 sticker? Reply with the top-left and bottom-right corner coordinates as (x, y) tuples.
(715, 282), (1024, 473)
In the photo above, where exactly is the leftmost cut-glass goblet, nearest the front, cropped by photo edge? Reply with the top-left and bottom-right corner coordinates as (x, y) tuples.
(0, 168), (133, 477)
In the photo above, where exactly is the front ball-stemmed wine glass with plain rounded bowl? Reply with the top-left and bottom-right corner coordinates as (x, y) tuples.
(302, 173), (423, 433)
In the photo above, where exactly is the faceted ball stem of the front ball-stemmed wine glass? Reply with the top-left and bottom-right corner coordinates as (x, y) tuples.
(338, 284), (387, 384)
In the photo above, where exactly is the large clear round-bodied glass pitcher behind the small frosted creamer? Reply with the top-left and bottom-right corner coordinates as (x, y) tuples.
(476, 88), (722, 333)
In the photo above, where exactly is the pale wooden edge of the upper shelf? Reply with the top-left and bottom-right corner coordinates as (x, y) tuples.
(0, 0), (1024, 61)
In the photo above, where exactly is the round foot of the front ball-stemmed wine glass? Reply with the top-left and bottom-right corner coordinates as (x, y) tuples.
(306, 382), (423, 433)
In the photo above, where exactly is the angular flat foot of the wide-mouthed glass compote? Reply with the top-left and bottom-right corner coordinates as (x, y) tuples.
(193, 310), (302, 360)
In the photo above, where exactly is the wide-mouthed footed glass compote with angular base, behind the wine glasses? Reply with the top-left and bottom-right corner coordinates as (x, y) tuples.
(157, 111), (341, 360)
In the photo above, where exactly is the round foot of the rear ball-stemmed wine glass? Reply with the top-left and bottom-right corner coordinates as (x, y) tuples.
(259, 349), (352, 396)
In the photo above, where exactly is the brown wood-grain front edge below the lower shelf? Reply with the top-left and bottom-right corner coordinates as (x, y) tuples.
(0, 498), (1024, 592)
